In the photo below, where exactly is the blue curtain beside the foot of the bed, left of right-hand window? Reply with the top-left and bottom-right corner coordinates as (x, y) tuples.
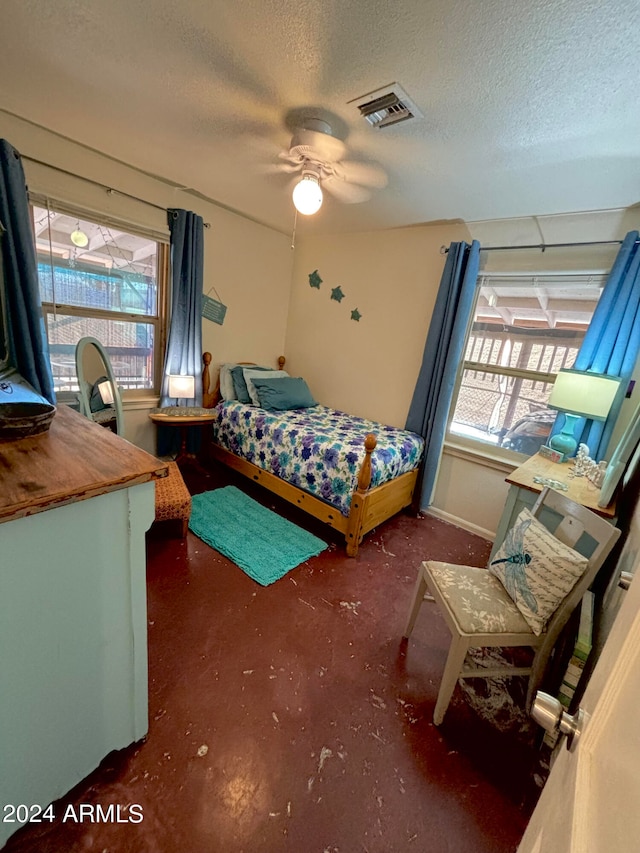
(406, 240), (480, 509)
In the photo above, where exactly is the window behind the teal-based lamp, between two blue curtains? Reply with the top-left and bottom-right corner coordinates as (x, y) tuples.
(449, 273), (606, 456)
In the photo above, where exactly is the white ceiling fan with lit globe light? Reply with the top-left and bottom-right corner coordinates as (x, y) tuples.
(278, 118), (387, 215)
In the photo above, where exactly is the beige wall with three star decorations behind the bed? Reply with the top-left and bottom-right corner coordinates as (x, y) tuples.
(286, 224), (468, 427)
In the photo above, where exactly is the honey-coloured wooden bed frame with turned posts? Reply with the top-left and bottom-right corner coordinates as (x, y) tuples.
(202, 352), (418, 557)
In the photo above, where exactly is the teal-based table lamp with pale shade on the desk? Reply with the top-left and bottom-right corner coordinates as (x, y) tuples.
(547, 368), (622, 460)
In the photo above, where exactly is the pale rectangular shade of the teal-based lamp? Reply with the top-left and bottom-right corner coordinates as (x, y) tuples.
(547, 370), (622, 421)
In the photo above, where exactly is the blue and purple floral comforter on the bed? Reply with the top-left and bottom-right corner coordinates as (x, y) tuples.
(213, 401), (424, 515)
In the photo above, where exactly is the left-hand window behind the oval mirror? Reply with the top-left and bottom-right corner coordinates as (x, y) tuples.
(32, 205), (168, 393)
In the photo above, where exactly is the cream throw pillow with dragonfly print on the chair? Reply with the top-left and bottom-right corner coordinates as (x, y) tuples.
(489, 509), (588, 636)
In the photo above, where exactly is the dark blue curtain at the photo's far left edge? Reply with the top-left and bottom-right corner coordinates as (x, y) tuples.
(0, 139), (56, 404)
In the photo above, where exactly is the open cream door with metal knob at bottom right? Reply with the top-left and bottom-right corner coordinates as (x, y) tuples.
(518, 553), (640, 853)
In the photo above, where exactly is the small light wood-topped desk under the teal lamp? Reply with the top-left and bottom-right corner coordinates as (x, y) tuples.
(490, 453), (616, 559)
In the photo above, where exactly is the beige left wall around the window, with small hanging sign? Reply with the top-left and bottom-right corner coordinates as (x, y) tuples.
(0, 111), (293, 452)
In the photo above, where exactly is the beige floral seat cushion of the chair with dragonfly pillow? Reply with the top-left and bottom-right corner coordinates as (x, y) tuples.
(424, 561), (531, 634)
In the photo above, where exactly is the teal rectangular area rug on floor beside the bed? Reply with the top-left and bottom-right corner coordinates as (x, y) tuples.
(189, 486), (327, 586)
